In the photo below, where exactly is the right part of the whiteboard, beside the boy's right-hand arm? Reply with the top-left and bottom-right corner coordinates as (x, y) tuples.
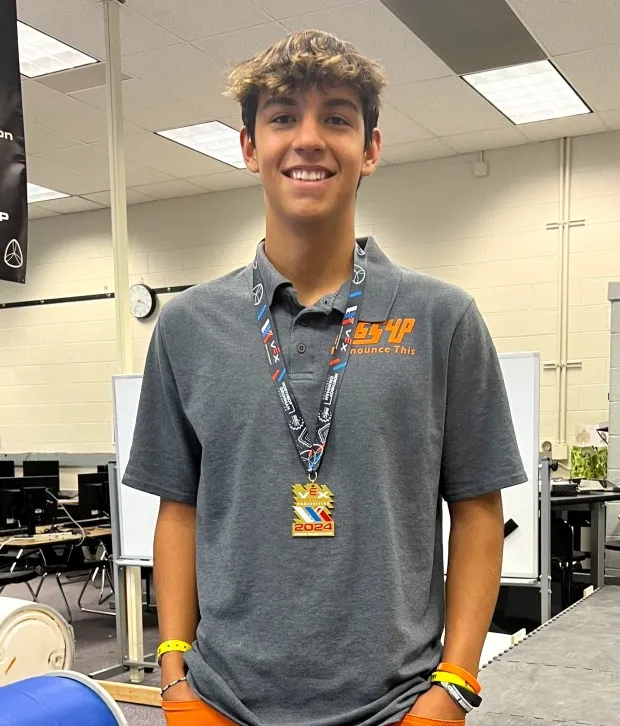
(443, 353), (540, 580)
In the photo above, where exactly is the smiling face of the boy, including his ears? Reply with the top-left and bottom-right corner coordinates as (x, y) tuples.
(241, 87), (381, 228)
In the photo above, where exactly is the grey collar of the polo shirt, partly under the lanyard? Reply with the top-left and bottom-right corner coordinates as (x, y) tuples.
(253, 237), (401, 323)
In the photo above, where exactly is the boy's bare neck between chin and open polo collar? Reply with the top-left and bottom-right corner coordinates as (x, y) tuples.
(265, 217), (355, 307)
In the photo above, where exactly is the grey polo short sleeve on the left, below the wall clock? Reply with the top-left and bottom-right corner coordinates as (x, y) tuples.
(123, 318), (201, 504)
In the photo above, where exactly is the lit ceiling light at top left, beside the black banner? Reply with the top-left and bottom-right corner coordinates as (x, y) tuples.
(17, 21), (99, 78)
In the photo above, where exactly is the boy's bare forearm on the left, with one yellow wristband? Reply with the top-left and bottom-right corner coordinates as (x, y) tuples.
(153, 501), (199, 683)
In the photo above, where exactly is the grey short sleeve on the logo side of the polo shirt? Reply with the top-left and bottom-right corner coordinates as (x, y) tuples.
(440, 300), (527, 502)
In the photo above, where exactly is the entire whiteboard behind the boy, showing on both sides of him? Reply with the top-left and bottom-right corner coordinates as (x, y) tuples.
(112, 353), (540, 580)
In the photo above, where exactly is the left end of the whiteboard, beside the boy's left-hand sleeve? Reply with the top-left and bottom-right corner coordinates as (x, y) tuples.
(112, 375), (159, 566)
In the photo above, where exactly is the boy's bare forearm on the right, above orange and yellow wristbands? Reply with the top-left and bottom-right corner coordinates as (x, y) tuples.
(443, 492), (504, 675)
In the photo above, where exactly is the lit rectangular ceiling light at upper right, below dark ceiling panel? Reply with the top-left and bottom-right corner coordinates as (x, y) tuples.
(463, 61), (591, 124)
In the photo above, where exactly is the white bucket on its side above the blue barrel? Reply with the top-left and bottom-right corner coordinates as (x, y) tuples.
(0, 597), (75, 686)
